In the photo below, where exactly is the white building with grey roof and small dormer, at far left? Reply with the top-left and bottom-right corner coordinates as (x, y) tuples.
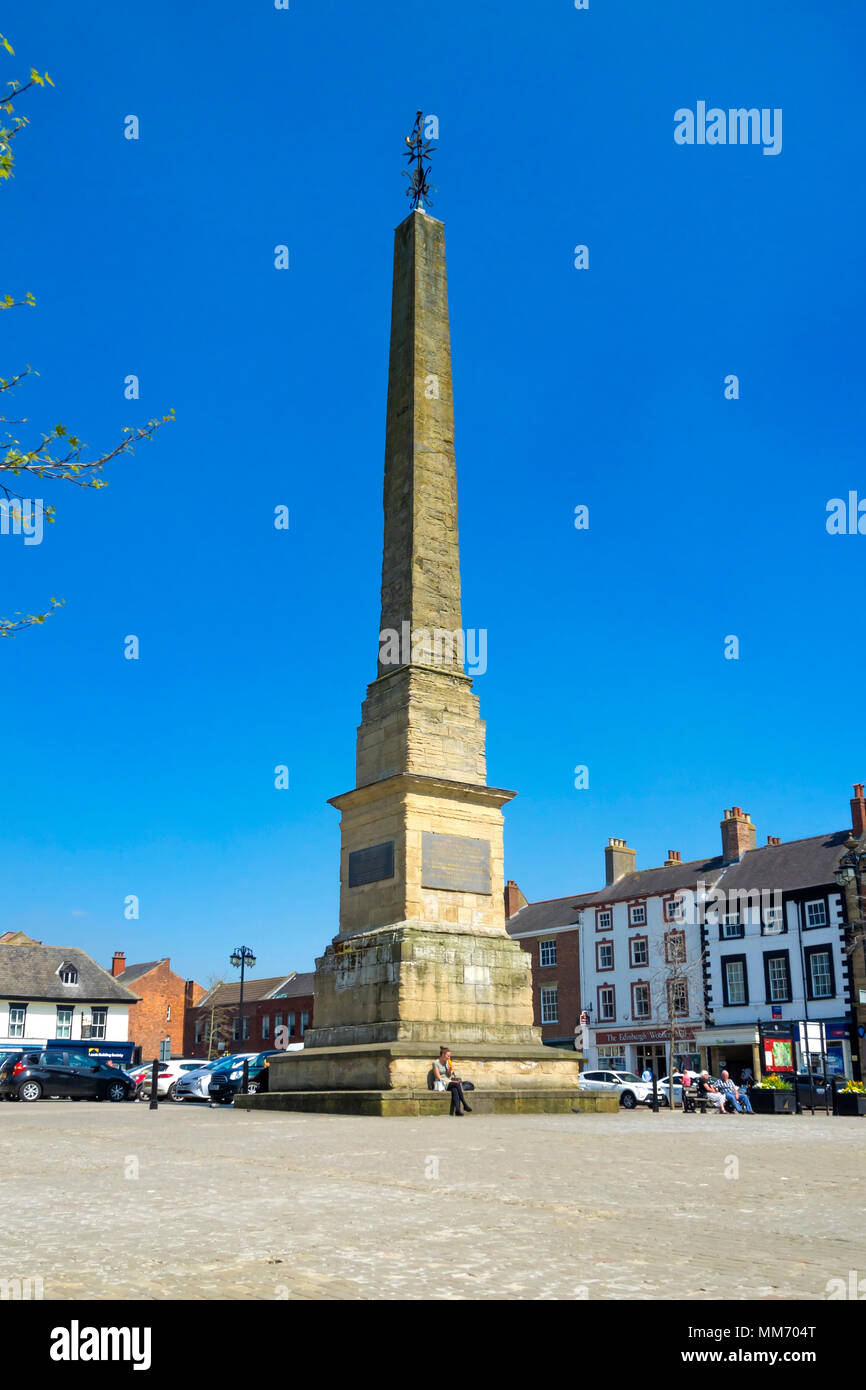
(0, 933), (139, 1049)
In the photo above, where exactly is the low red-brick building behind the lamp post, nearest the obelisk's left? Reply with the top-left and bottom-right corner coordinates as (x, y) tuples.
(183, 970), (313, 1058)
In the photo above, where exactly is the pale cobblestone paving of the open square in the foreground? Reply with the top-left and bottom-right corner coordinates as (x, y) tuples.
(0, 1101), (866, 1300)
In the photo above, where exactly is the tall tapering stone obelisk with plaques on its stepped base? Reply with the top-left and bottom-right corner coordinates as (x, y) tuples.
(270, 132), (577, 1113)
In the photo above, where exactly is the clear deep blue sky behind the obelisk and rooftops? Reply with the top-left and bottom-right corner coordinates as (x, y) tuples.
(0, 0), (866, 979)
